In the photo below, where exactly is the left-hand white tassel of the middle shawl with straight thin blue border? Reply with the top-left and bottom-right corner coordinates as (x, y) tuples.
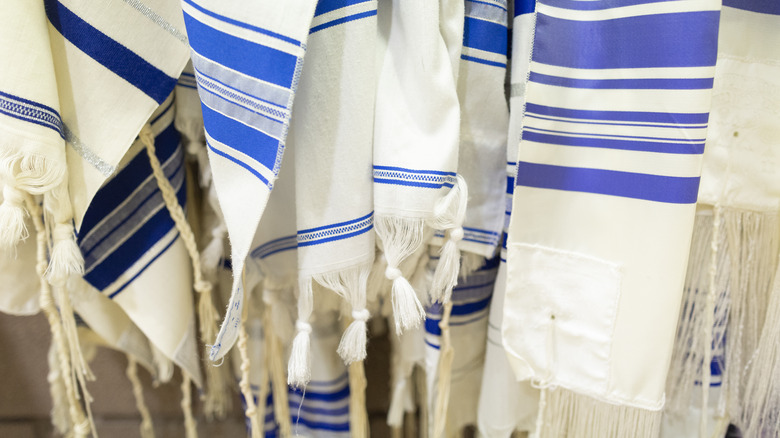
(375, 216), (425, 334)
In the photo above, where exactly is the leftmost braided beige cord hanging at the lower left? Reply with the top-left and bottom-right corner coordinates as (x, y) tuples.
(25, 195), (92, 438)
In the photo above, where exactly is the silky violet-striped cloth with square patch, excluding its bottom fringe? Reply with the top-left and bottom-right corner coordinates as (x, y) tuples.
(502, 2), (719, 411)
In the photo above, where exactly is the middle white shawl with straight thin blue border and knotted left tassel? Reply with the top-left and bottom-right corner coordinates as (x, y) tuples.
(373, 0), (465, 332)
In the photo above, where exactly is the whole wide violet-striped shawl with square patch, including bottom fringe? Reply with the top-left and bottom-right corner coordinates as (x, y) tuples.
(502, 0), (720, 437)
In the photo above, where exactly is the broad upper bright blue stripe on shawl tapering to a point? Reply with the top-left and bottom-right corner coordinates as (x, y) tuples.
(184, 13), (298, 88)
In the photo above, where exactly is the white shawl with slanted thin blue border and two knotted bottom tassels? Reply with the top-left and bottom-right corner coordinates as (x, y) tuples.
(287, 0), (377, 386)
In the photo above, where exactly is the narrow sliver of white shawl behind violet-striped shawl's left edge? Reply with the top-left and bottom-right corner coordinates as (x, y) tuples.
(477, 0), (538, 437)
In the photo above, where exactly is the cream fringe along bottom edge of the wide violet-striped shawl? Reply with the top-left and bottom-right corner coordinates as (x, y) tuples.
(536, 388), (662, 438)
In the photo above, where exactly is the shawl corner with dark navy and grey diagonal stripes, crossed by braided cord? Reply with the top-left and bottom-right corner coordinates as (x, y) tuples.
(78, 102), (200, 385)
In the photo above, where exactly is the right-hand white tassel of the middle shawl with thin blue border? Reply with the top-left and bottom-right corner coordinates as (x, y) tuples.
(430, 175), (469, 303)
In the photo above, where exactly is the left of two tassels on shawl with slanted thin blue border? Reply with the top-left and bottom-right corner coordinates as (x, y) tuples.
(287, 278), (314, 387)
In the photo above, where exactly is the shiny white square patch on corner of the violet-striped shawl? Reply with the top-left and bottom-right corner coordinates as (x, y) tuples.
(502, 244), (622, 395)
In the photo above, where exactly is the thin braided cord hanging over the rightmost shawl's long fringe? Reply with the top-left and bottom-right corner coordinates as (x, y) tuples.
(699, 204), (722, 438)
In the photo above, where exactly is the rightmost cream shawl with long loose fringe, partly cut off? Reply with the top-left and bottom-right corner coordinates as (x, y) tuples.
(663, 0), (780, 437)
